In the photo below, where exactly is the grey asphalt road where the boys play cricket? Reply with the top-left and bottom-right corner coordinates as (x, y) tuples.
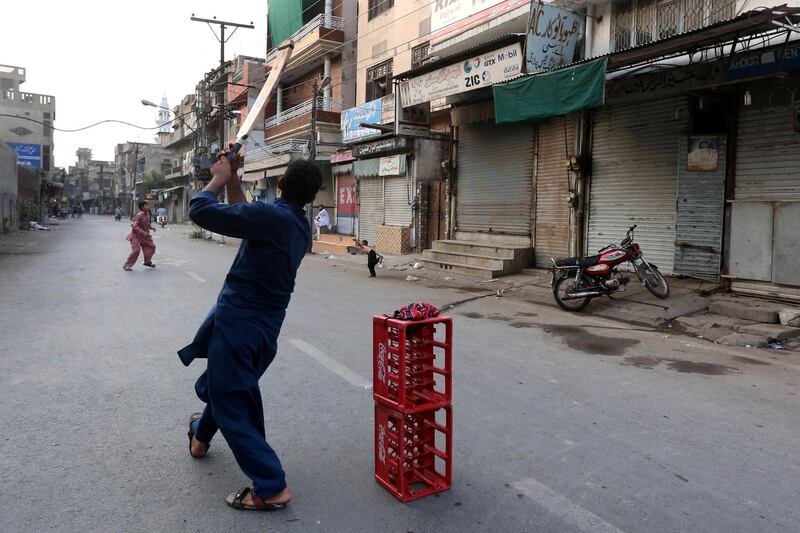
(0, 216), (800, 533)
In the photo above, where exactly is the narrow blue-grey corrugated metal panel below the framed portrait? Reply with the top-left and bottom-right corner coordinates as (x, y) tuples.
(675, 135), (726, 281)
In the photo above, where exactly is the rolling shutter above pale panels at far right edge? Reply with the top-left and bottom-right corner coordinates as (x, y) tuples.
(735, 94), (800, 202)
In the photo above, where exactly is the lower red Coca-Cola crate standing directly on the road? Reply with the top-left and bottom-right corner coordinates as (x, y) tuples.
(375, 403), (453, 502)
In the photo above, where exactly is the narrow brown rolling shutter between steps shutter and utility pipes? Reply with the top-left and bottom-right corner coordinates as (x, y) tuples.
(533, 117), (575, 267)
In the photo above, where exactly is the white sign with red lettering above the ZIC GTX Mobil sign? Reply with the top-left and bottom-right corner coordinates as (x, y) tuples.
(431, 0), (530, 45)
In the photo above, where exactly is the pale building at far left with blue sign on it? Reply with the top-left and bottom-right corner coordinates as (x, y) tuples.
(0, 65), (56, 174)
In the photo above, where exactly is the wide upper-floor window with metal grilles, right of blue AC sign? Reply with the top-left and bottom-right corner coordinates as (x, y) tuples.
(611, 0), (735, 52)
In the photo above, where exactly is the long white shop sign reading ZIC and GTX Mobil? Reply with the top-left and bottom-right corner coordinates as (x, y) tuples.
(399, 43), (524, 107)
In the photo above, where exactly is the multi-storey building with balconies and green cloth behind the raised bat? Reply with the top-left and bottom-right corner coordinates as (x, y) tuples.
(244, 0), (357, 212)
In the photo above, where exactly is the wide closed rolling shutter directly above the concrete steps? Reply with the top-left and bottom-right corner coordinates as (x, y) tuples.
(456, 124), (534, 235)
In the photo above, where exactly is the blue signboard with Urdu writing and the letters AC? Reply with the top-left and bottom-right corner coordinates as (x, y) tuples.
(525, 2), (583, 74)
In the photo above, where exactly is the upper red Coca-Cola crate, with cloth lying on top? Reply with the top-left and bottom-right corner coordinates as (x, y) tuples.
(372, 316), (453, 412)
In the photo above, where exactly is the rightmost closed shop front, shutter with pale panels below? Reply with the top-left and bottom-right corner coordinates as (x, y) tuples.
(728, 76), (800, 299)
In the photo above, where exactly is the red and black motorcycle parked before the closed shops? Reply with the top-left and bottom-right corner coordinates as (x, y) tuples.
(550, 225), (669, 311)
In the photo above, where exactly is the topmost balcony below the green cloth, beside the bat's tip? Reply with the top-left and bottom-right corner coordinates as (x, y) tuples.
(267, 14), (344, 72)
